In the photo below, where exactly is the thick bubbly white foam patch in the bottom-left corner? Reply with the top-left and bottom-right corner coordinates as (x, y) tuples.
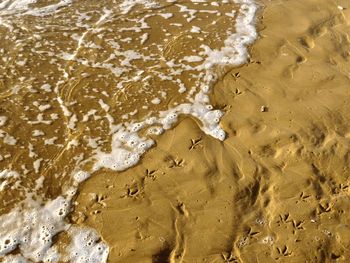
(0, 193), (109, 263)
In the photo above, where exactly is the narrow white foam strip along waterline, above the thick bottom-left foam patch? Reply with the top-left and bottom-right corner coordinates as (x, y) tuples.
(93, 0), (257, 171)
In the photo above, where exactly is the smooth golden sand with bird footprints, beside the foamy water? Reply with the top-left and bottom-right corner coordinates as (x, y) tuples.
(71, 0), (350, 263)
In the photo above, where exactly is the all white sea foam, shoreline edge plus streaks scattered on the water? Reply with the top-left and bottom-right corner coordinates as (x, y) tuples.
(0, 0), (257, 263)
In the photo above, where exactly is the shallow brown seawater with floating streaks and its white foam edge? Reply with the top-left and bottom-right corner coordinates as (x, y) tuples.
(0, 0), (257, 262)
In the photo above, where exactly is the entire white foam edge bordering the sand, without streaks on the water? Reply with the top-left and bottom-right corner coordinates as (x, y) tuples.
(0, 0), (257, 263)
